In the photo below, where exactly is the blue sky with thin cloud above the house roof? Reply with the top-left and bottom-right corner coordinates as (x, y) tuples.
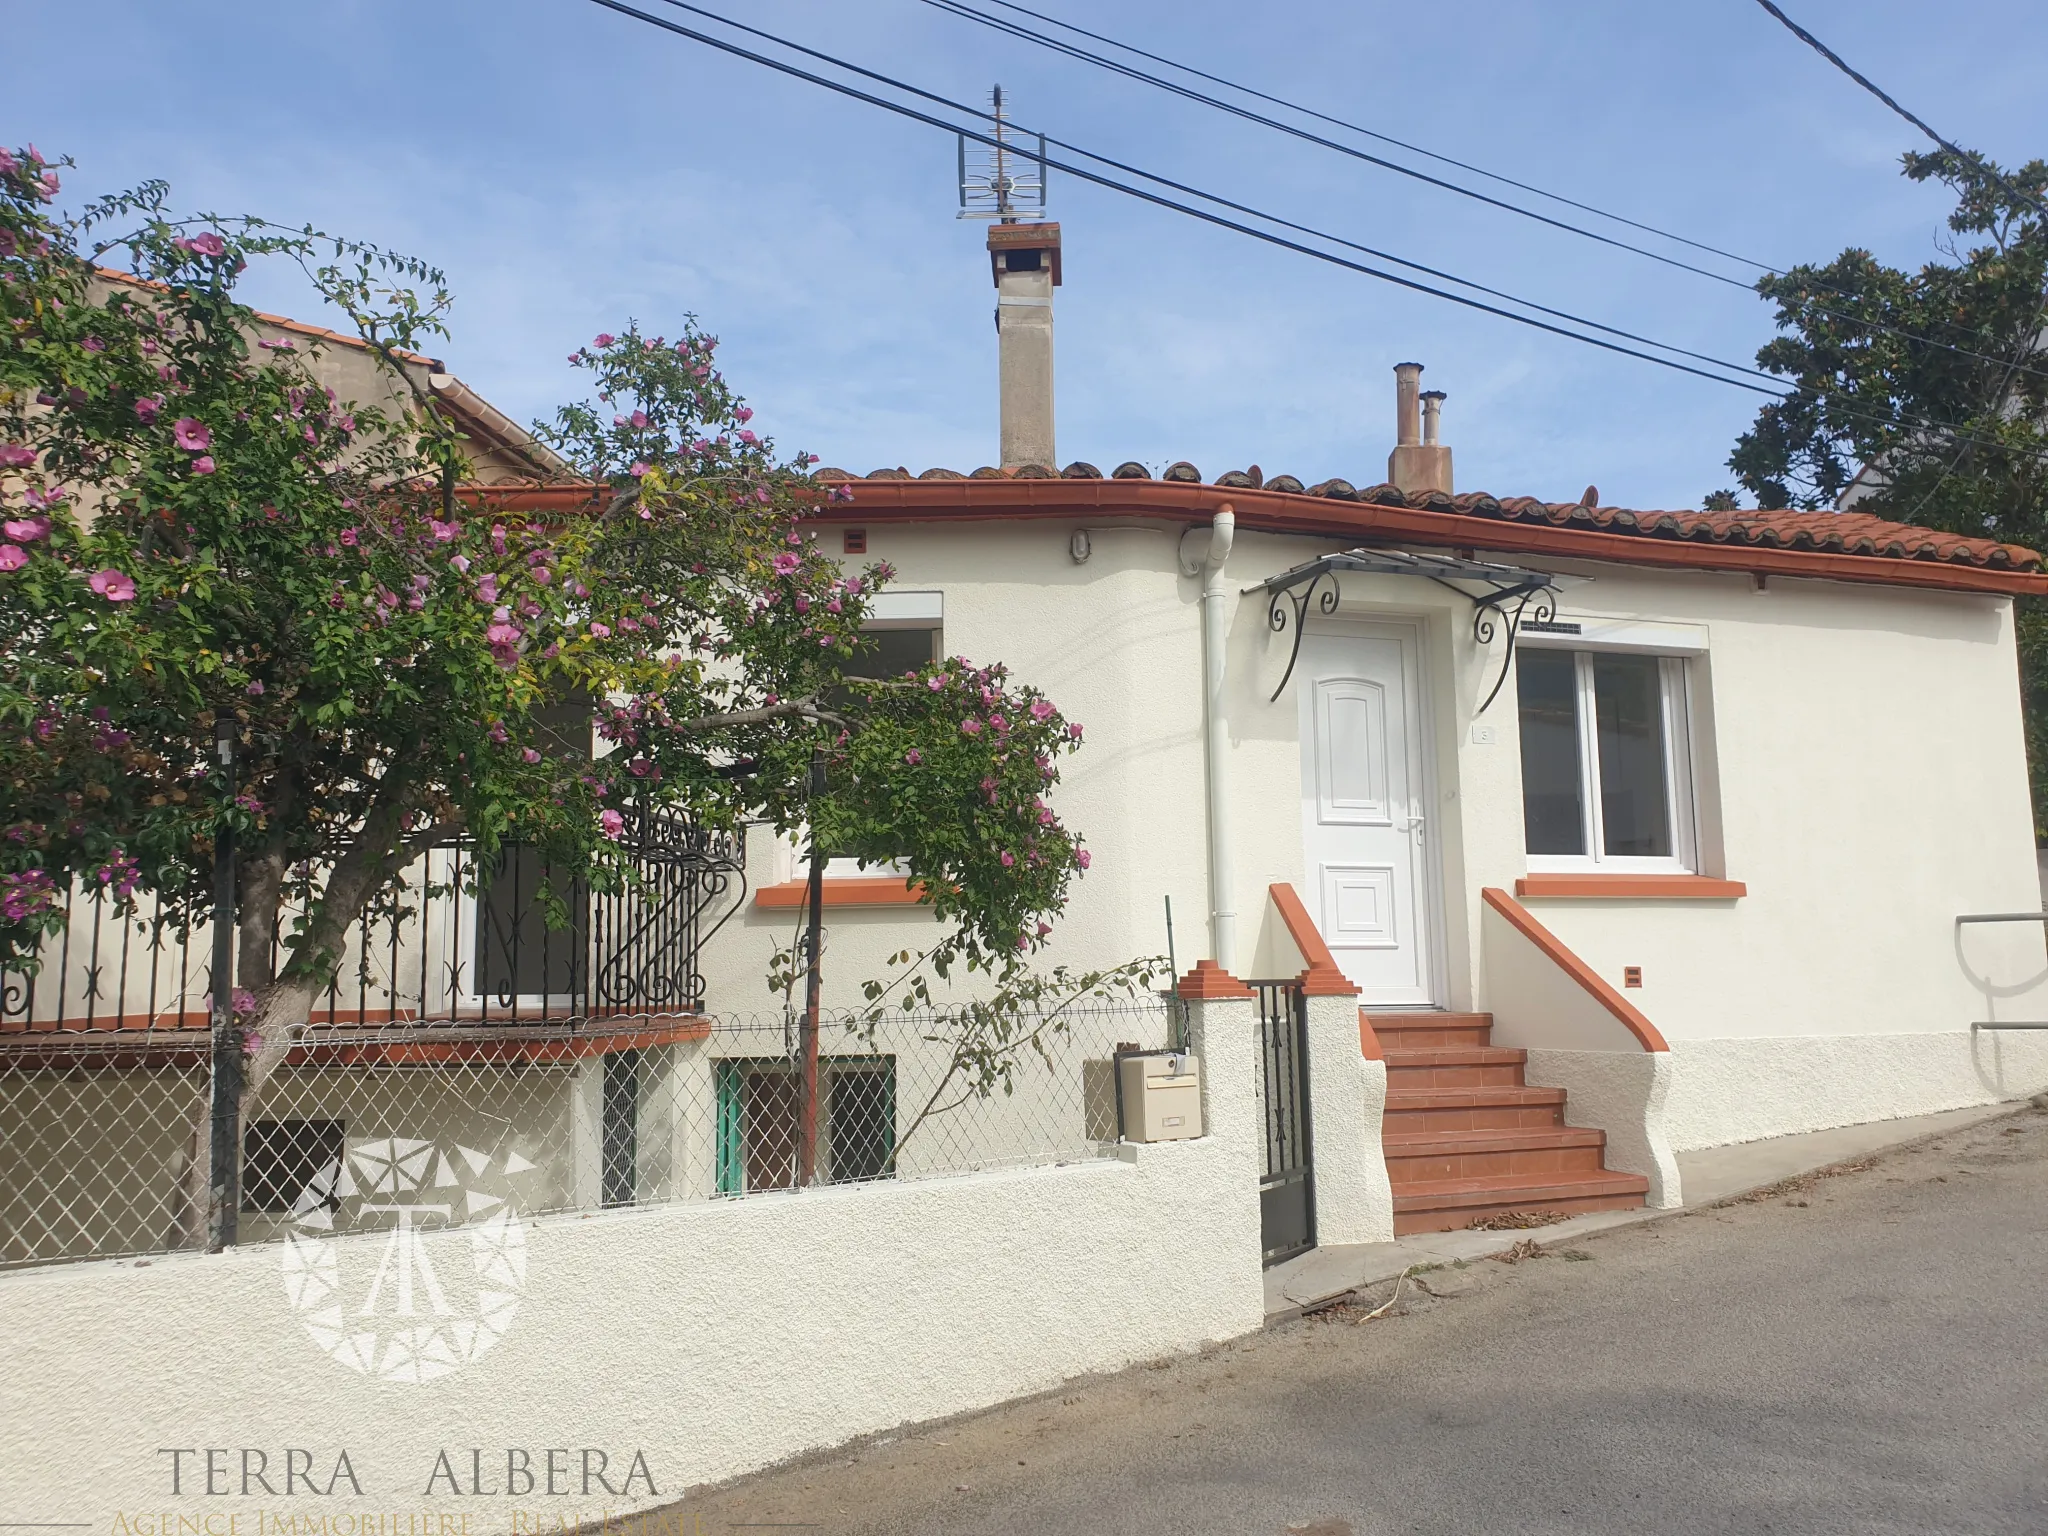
(16, 0), (2048, 508)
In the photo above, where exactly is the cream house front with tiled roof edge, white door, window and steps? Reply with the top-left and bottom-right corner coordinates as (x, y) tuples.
(707, 442), (2048, 1235)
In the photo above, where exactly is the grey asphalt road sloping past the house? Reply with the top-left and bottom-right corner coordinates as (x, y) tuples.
(686, 1110), (2048, 1536)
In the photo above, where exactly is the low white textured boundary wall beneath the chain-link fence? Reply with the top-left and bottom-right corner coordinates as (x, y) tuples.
(0, 999), (1264, 1536)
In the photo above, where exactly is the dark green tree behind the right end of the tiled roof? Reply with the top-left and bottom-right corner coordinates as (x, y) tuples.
(1729, 152), (2048, 838)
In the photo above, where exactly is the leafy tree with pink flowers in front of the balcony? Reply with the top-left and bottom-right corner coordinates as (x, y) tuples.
(0, 147), (1138, 1090)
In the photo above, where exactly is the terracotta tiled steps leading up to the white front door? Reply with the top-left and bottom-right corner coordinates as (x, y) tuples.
(1368, 1014), (1649, 1235)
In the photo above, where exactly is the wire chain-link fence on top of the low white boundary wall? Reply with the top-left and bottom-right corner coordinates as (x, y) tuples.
(0, 987), (1174, 1268)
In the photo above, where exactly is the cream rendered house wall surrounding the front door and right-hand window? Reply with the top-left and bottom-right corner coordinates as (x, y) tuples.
(713, 520), (2048, 1147)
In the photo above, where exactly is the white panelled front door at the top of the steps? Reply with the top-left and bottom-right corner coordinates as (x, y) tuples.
(1294, 627), (1438, 1008)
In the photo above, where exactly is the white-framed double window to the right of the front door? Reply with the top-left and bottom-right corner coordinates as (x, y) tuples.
(1516, 645), (1700, 874)
